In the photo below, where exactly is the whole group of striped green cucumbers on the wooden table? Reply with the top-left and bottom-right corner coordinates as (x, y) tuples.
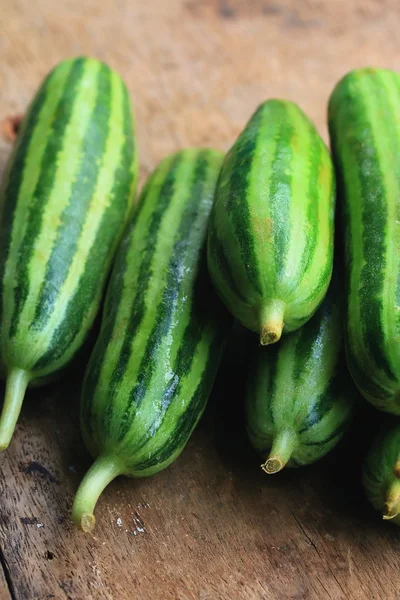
(0, 57), (400, 531)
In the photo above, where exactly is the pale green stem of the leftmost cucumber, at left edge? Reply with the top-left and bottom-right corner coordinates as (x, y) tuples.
(0, 369), (30, 451)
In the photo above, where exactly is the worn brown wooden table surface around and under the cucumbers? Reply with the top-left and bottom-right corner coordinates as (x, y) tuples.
(0, 0), (400, 600)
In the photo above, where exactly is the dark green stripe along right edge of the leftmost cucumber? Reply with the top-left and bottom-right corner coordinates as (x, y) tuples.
(34, 83), (135, 370)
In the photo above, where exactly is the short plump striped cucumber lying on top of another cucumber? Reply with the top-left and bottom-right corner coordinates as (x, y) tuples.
(208, 100), (335, 345)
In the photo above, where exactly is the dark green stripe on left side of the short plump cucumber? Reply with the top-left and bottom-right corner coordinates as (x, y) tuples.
(225, 105), (264, 295)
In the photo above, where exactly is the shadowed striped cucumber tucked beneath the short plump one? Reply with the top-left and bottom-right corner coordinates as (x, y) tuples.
(246, 278), (357, 473)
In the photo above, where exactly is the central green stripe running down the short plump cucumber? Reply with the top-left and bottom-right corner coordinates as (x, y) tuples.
(269, 103), (296, 280)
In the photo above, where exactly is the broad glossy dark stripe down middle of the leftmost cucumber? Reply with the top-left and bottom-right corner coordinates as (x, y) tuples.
(31, 64), (111, 331)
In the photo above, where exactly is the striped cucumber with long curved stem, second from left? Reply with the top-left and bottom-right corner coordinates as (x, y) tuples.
(72, 149), (230, 531)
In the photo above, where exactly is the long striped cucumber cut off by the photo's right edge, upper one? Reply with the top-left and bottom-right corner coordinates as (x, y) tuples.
(329, 69), (400, 414)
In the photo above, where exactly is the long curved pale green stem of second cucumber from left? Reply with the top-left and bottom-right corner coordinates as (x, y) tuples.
(72, 456), (122, 533)
